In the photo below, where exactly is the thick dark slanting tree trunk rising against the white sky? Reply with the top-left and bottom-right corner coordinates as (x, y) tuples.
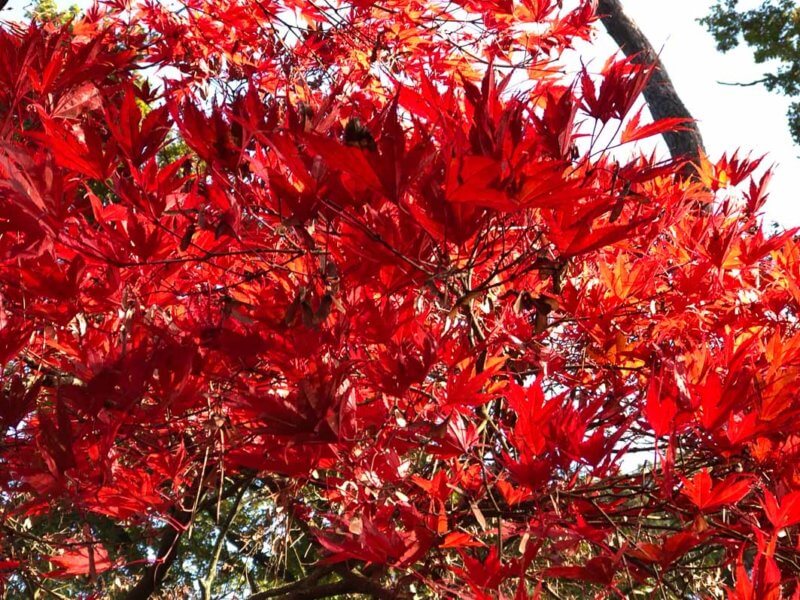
(597, 0), (705, 163)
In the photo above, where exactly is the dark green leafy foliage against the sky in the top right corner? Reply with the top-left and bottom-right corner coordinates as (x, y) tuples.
(700, 0), (800, 144)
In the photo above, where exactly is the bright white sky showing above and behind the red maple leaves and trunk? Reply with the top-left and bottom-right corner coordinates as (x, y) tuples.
(3, 0), (800, 227)
